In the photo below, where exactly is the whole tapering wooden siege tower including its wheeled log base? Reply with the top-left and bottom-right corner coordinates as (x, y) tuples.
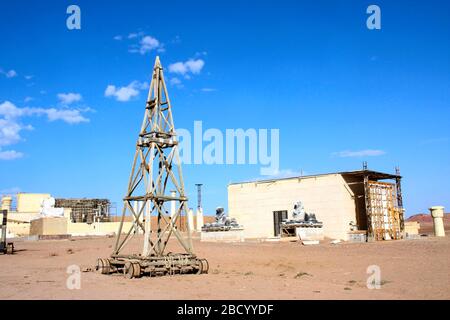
(96, 57), (208, 278)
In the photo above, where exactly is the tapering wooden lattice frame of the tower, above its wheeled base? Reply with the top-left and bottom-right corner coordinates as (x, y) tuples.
(113, 58), (192, 258)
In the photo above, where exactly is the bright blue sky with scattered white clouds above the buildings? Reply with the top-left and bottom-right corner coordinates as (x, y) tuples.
(0, 0), (450, 215)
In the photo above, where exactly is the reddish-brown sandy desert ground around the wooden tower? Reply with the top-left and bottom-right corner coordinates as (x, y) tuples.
(0, 228), (450, 299)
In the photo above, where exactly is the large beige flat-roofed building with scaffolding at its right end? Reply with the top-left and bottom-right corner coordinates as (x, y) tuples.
(228, 170), (404, 240)
